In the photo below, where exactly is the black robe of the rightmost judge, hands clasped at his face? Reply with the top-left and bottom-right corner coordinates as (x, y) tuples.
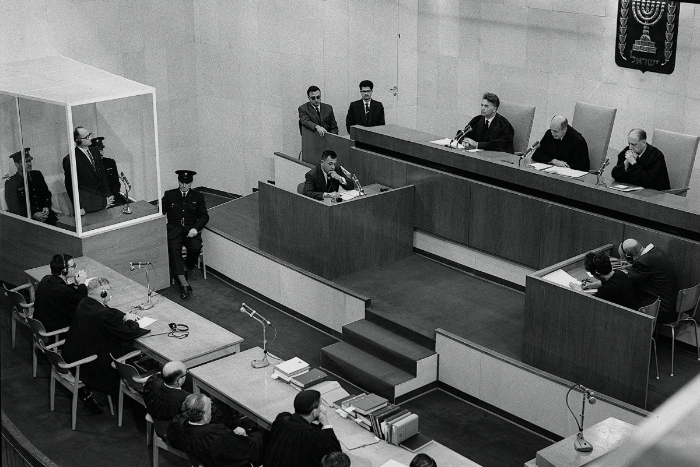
(612, 144), (671, 190)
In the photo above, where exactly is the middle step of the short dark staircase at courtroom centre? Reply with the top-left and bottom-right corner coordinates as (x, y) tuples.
(343, 319), (435, 376)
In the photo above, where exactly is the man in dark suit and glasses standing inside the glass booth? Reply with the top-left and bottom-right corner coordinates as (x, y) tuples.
(63, 126), (114, 214)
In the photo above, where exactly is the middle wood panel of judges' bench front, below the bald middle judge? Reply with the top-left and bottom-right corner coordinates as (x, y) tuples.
(469, 183), (545, 267)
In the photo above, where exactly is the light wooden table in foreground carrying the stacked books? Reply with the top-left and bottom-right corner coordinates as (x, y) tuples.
(190, 347), (478, 467)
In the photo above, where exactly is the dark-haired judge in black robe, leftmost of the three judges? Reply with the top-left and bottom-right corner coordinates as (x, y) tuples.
(463, 92), (515, 154)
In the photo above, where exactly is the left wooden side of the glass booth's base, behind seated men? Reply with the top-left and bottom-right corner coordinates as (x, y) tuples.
(0, 214), (83, 285)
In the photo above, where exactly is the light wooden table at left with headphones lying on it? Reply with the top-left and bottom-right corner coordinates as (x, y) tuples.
(26, 256), (243, 368)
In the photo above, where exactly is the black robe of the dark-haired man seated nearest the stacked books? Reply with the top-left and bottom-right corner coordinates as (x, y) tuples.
(264, 412), (341, 467)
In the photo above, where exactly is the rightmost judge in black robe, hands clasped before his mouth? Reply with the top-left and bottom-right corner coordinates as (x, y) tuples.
(611, 129), (671, 191)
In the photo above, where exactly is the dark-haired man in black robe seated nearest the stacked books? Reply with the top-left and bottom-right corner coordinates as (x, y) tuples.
(264, 389), (342, 467)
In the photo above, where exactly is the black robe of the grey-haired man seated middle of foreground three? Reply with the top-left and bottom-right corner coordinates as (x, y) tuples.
(166, 415), (262, 467)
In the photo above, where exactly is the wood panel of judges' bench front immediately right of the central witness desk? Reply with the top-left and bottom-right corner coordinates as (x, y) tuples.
(407, 164), (472, 245)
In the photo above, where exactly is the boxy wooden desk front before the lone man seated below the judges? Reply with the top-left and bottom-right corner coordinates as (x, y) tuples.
(258, 182), (413, 280)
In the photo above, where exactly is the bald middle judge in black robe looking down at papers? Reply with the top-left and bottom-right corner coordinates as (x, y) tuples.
(532, 115), (591, 172)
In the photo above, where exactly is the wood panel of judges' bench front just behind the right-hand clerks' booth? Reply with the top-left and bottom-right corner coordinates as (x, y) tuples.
(539, 204), (623, 268)
